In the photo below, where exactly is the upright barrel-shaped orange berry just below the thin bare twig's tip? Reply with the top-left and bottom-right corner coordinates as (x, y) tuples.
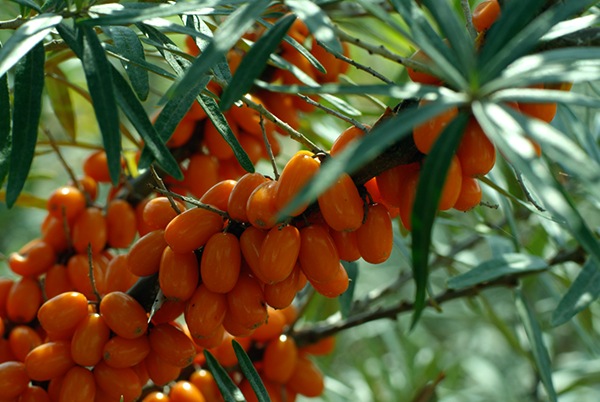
(200, 233), (242, 293)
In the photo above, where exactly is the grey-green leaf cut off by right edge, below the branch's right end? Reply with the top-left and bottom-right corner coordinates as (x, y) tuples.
(550, 258), (600, 327)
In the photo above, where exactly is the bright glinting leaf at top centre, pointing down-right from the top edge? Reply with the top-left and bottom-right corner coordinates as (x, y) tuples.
(285, 0), (342, 52)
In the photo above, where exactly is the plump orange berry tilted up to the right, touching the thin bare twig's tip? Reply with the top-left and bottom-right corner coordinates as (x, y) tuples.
(165, 208), (223, 253)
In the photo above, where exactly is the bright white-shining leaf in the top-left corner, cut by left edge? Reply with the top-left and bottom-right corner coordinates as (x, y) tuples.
(0, 14), (62, 76)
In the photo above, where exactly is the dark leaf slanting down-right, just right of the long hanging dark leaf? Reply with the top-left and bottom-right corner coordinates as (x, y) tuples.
(111, 66), (183, 180)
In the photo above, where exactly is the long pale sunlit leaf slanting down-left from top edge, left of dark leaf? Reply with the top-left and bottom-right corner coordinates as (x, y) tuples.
(165, 0), (269, 102)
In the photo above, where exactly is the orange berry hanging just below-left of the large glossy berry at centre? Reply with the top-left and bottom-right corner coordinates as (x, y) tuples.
(298, 225), (340, 283)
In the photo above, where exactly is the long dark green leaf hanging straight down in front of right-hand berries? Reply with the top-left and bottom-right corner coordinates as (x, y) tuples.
(411, 113), (469, 328)
